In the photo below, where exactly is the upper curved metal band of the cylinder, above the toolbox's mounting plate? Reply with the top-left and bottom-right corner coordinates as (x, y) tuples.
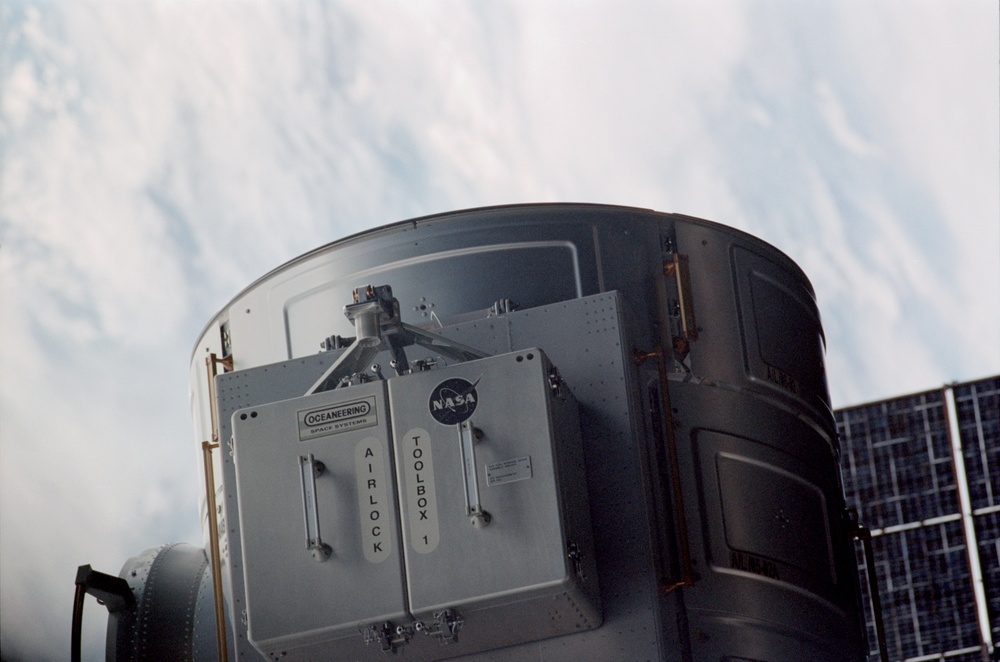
(198, 204), (832, 438)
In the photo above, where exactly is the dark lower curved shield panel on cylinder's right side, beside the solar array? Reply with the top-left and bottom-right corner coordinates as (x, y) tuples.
(670, 381), (863, 662)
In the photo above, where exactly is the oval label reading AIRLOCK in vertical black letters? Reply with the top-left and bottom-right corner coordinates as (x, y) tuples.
(354, 437), (392, 563)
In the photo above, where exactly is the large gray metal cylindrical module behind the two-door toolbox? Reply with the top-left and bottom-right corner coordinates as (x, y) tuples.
(107, 204), (867, 662)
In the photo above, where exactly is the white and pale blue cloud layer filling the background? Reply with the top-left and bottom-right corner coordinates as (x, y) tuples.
(0, 0), (1000, 660)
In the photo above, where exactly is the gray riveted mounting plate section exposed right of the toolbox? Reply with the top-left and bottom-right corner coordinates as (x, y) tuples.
(437, 292), (668, 662)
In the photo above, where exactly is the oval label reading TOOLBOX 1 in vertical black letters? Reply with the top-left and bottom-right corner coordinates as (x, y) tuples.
(399, 428), (441, 554)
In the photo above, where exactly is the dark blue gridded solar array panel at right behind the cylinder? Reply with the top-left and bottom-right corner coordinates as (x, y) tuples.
(836, 377), (1000, 662)
